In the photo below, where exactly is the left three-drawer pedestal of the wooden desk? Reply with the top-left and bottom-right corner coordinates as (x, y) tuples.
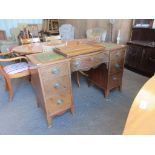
(29, 56), (74, 127)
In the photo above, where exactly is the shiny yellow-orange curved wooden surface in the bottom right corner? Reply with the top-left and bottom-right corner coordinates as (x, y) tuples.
(123, 75), (155, 135)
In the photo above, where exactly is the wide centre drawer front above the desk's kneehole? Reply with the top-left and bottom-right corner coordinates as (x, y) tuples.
(71, 52), (109, 71)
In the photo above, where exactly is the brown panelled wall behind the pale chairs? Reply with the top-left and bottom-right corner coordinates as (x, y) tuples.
(59, 19), (132, 43)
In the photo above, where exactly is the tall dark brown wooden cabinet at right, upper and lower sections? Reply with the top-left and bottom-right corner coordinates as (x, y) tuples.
(125, 20), (155, 76)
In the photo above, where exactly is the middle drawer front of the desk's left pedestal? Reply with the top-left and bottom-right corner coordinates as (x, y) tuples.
(43, 76), (71, 98)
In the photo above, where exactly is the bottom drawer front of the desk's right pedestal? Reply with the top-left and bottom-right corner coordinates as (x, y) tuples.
(109, 73), (122, 89)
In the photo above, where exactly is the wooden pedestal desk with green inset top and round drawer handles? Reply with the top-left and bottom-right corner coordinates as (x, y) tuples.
(27, 42), (125, 126)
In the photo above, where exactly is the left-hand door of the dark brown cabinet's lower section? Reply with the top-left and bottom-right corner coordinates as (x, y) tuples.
(125, 45), (143, 69)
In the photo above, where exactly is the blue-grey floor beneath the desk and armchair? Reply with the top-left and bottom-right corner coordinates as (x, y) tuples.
(0, 70), (148, 135)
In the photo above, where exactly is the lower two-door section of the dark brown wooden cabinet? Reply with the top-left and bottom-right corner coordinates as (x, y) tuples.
(125, 44), (155, 76)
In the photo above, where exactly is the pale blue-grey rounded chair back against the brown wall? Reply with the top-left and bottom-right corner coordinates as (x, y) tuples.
(59, 24), (74, 40)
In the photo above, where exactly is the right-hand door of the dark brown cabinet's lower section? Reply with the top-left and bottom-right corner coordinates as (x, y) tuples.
(141, 48), (155, 73)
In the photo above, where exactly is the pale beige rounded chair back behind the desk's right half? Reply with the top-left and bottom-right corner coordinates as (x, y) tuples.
(86, 28), (107, 42)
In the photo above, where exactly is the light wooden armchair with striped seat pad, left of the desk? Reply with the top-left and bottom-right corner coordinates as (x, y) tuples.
(0, 52), (30, 101)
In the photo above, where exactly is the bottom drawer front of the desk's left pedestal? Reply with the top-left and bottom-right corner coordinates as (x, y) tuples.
(46, 93), (72, 115)
